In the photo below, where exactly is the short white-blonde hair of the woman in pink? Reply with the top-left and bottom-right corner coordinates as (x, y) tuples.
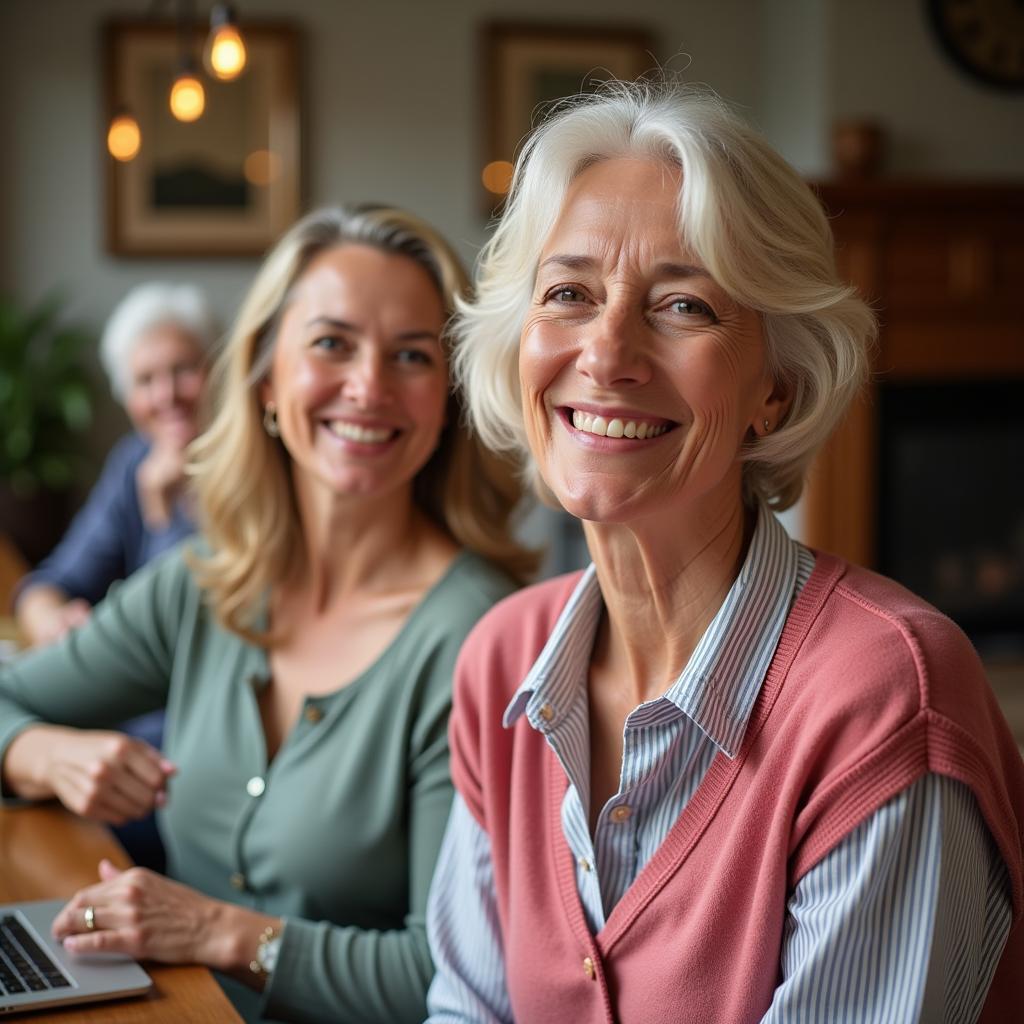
(454, 83), (876, 509)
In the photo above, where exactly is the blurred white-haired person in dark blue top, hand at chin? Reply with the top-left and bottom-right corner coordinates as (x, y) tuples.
(14, 282), (217, 643)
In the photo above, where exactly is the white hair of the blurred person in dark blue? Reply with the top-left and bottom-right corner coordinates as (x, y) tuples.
(99, 281), (218, 401)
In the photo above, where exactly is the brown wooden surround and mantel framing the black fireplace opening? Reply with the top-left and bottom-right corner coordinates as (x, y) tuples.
(804, 181), (1024, 566)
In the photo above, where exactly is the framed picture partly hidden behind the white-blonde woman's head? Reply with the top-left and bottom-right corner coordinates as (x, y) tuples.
(480, 22), (656, 212)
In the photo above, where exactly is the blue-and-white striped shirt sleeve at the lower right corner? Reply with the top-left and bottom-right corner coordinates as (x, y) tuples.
(763, 775), (1012, 1024)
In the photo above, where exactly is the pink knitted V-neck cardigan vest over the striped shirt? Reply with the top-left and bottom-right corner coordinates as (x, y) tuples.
(451, 555), (1024, 1024)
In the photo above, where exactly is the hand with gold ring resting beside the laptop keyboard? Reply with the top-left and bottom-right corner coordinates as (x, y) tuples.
(53, 860), (224, 967)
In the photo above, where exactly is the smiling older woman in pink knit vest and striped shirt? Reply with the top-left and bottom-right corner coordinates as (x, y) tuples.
(428, 86), (1024, 1024)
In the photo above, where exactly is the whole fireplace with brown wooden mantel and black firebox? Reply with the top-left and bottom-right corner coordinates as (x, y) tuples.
(803, 179), (1024, 750)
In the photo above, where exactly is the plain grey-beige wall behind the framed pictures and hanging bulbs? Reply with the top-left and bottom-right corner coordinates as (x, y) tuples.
(0, 0), (1024, 471)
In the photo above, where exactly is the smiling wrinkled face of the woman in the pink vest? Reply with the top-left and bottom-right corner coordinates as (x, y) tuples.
(519, 159), (779, 523)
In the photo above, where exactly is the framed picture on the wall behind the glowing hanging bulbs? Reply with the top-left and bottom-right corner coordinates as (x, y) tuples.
(104, 20), (301, 258)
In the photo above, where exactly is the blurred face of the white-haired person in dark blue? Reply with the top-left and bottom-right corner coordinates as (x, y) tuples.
(125, 325), (207, 446)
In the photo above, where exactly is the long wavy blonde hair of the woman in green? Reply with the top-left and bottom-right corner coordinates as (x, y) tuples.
(189, 206), (537, 645)
